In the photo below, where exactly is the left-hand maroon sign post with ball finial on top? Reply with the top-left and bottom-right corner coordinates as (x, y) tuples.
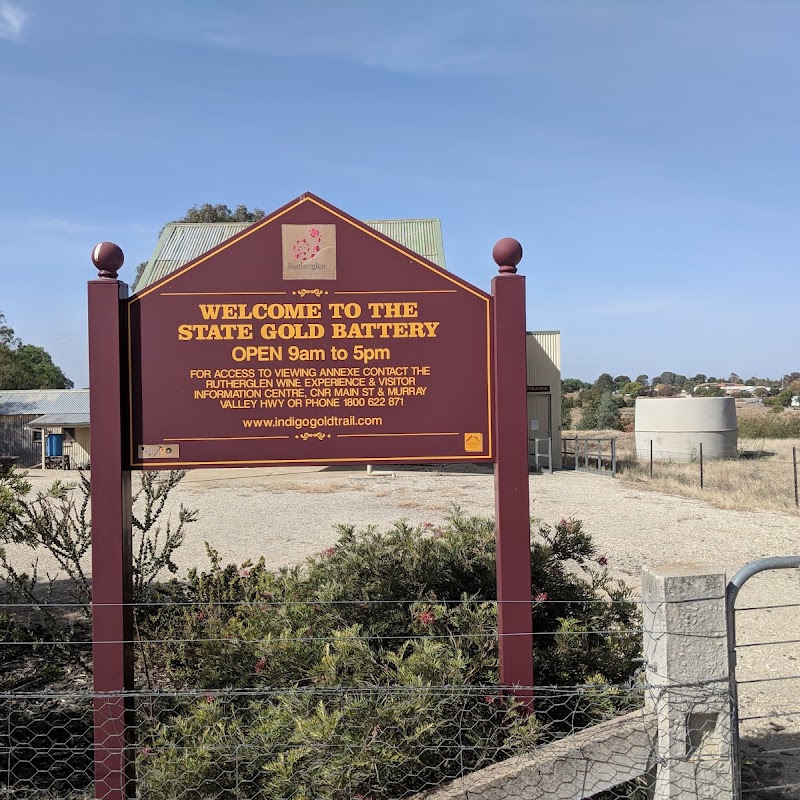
(88, 242), (134, 800)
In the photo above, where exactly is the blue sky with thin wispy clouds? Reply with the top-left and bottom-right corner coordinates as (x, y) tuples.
(0, 0), (800, 387)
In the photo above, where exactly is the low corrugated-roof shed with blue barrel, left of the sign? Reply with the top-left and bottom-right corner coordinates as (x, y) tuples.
(0, 389), (90, 469)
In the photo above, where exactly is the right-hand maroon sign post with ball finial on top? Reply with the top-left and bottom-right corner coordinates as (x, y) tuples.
(492, 239), (533, 707)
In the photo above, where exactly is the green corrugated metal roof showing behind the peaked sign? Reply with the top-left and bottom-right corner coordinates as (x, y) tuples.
(133, 219), (446, 292)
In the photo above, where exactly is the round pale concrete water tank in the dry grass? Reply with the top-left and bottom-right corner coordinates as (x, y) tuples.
(635, 397), (739, 461)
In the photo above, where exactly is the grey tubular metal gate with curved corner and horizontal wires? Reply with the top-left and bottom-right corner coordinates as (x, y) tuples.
(725, 556), (800, 799)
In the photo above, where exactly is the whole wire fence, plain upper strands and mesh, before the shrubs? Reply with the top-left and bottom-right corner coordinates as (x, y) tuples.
(0, 598), (760, 800)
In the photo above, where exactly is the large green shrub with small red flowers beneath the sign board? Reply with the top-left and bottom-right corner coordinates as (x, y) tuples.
(137, 512), (641, 800)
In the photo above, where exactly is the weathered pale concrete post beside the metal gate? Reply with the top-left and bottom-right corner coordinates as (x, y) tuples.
(642, 564), (735, 800)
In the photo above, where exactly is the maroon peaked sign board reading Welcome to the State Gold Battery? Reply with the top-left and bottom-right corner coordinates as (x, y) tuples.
(127, 194), (494, 469)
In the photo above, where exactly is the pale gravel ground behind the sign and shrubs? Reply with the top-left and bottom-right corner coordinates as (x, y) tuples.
(9, 467), (800, 797)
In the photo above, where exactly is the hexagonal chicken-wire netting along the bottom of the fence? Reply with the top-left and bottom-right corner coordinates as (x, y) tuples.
(0, 687), (646, 800)
